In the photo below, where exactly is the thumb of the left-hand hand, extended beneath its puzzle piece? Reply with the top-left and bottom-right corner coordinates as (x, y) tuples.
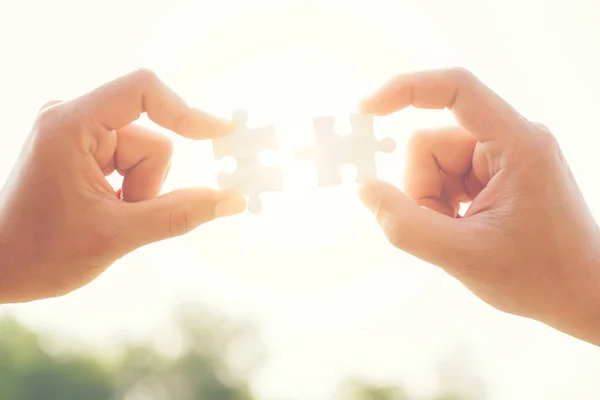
(123, 188), (246, 248)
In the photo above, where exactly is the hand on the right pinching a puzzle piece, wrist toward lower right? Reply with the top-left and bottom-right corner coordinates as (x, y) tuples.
(360, 69), (600, 345)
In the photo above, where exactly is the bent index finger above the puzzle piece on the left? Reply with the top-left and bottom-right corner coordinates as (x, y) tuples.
(75, 69), (235, 139)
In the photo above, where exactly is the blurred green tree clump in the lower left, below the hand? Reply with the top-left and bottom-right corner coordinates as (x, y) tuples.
(0, 311), (258, 400)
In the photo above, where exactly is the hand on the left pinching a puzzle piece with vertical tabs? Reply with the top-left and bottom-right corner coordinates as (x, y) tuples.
(0, 70), (245, 303)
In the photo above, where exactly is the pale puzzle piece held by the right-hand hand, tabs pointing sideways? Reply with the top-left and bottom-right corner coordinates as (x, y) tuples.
(296, 114), (396, 186)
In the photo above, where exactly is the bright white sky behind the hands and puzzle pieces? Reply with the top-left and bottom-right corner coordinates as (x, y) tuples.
(0, 0), (600, 400)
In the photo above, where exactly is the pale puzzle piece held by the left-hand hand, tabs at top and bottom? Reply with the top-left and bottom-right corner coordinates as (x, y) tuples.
(213, 110), (283, 214)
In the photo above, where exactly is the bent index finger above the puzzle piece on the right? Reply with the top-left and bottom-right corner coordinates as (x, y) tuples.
(360, 68), (526, 142)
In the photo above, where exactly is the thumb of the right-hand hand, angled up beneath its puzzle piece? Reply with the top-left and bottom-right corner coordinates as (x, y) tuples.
(359, 181), (469, 269)
